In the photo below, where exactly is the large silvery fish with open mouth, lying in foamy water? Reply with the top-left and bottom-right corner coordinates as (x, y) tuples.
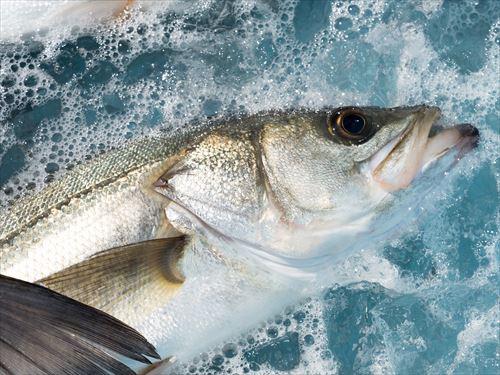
(0, 105), (479, 374)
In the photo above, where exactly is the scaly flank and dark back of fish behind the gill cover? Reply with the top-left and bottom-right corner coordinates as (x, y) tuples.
(0, 110), (306, 281)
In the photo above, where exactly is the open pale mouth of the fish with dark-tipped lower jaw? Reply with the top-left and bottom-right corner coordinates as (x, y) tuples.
(368, 106), (479, 192)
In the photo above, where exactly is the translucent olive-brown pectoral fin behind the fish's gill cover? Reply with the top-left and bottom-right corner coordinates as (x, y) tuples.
(39, 236), (186, 324)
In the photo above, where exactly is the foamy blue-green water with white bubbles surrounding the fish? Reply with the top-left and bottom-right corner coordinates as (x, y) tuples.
(0, 0), (500, 374)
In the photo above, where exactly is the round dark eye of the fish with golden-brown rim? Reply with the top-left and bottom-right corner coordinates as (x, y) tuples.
(328, 108), (372, 144)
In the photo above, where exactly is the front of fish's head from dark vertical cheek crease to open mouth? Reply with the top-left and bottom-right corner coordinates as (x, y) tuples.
(260, 106), (479, 264)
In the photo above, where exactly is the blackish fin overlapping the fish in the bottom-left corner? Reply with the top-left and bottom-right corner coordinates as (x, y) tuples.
(0, 275), (160, 375)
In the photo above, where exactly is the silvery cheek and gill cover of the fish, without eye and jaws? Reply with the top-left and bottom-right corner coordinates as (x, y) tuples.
(159, 106), (442, 256)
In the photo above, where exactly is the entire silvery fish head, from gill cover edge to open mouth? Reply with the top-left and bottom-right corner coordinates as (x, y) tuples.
(159, 106), (478, 272)
